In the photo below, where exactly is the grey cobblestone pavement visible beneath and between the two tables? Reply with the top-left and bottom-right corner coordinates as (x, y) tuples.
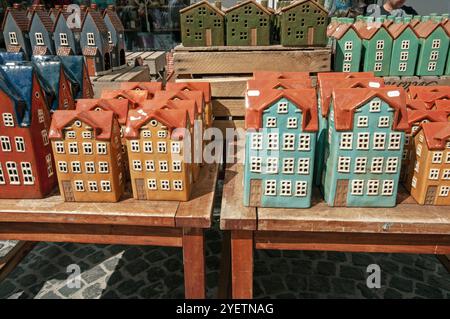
(0, 182), (450, 299)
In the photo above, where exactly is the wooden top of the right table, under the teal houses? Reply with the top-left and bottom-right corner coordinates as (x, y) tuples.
(220, 164), (450, 235)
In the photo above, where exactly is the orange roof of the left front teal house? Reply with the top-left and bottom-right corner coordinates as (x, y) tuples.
(245, 89), (319, 132)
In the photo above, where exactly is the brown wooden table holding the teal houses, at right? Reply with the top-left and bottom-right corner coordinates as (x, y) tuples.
(220, 164), (450, 298)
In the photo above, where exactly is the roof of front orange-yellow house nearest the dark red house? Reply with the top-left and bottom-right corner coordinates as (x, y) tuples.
(48, 110), (114, 140)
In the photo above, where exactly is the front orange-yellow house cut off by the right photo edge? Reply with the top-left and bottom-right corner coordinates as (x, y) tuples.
(411, 122), (450, 205)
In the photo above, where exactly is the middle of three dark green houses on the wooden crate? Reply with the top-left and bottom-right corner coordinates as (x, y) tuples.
(225, 0), (273, 46)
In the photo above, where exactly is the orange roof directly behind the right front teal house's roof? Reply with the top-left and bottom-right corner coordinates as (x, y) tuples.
(319, 78), (384, 117)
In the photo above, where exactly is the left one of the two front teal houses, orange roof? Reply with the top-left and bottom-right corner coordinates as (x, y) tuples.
(244, 89), (318, 208)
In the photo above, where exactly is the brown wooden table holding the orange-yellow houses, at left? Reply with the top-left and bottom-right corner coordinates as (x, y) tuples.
(0, 165), (218, 298)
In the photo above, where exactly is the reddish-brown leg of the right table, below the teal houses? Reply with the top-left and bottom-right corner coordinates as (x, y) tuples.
(231, 230), (253, 299)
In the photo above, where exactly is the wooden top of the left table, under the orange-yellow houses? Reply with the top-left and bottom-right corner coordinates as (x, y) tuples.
(0, 164), (218, 228)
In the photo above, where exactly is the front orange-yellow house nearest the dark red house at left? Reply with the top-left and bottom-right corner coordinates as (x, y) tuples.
(49, 110), (125, 202)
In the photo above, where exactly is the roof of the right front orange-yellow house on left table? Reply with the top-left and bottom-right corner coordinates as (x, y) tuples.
(124, 108), (188, 139)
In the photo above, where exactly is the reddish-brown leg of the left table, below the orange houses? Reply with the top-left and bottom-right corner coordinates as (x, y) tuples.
(183, 228), (206, 299)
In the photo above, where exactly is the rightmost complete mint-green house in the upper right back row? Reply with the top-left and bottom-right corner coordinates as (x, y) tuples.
(415, 17), (450, 76)
